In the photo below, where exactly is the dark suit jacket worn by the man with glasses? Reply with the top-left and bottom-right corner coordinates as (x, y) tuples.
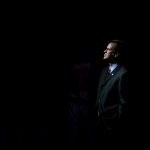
(97, 65), (128, 130)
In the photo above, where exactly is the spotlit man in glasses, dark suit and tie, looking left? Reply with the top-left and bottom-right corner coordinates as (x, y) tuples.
(96, 40), (128, 143)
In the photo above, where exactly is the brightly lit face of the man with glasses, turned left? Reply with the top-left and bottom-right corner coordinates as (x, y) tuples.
(103, 43), (118, 60)
